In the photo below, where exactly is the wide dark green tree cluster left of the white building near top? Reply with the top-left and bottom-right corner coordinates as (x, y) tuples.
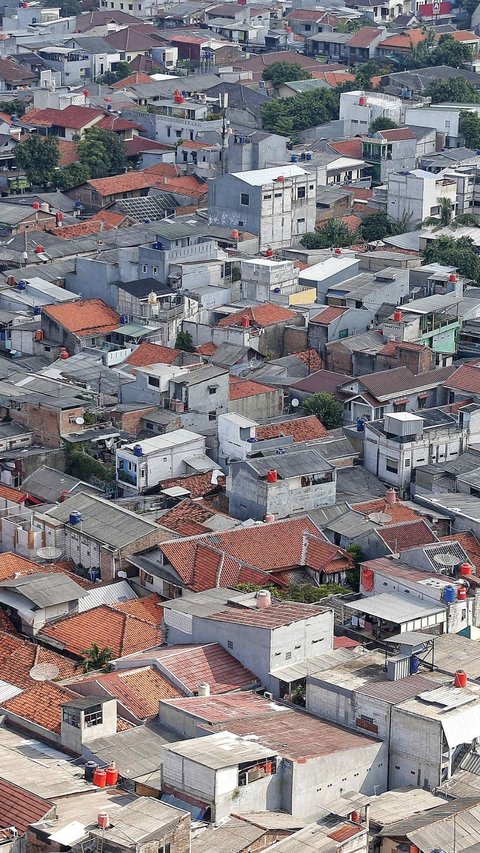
(262, 89), (340, 140)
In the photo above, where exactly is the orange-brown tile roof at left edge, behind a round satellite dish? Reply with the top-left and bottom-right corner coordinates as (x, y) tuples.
(0, 631), (76, 690)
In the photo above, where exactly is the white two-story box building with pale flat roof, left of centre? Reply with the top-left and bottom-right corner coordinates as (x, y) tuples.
(115, 429), (217, 496)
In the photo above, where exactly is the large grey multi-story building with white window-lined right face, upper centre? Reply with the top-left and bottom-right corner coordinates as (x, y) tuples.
(208, 164), (317, 249)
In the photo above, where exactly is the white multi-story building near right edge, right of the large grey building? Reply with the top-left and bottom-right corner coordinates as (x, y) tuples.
(386, 169), (457, 228)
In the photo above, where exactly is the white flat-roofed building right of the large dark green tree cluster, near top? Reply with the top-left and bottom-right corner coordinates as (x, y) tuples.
(340, 90), (403, 136)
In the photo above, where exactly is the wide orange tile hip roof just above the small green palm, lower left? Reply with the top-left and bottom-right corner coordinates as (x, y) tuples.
(39, 604), (162, 658)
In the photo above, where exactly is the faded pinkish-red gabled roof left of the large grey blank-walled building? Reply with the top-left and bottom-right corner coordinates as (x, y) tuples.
(131, 643), (258, 694)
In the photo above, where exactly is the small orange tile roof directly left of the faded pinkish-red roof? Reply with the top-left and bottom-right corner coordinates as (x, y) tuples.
(82, 666), (182, 720)
